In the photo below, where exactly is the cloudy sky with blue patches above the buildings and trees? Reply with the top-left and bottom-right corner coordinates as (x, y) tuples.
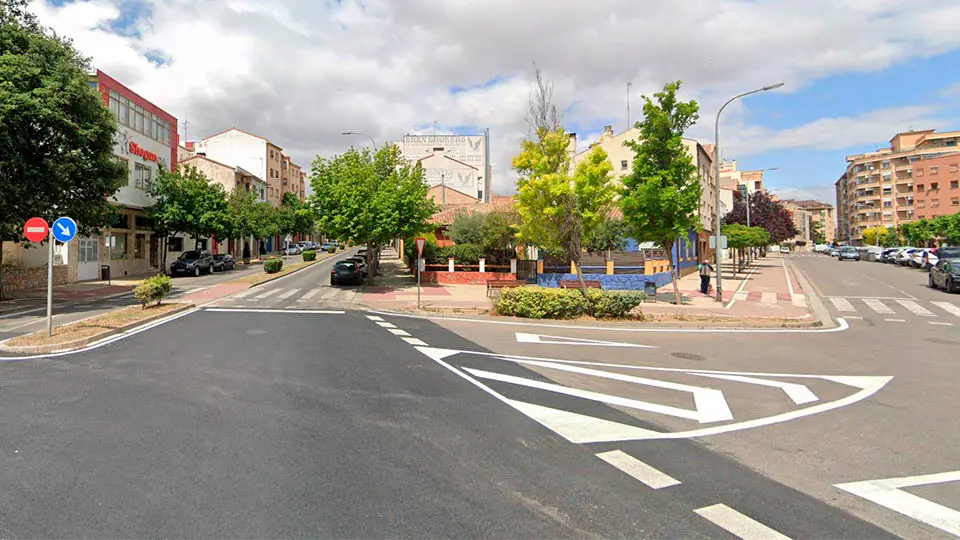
(26, 0), (960, 204)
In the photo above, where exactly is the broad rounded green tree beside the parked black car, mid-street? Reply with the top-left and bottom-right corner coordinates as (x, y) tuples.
(310, 145), (436, 276)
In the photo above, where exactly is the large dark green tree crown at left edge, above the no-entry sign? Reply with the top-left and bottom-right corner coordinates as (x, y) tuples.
(0, 0), (128, 296)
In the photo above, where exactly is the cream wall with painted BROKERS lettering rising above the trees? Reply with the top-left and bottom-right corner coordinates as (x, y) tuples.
(397, 129), (493, 202)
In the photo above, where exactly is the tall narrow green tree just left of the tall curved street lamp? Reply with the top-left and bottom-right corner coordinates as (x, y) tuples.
(620, 81), (701, 305)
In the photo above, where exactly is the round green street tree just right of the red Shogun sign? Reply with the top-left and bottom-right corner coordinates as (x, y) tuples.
(150, 166), (235, 267)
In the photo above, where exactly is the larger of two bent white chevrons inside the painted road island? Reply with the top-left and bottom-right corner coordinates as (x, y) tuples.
(463, 362), (733, 424)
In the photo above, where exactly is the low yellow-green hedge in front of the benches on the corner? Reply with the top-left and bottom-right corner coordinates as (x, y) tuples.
(496, 287), (646, 319)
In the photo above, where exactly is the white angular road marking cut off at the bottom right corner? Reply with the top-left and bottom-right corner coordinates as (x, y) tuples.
(834, 471), (960, 536)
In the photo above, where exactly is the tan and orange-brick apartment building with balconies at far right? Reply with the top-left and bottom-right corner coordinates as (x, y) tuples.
(836, 129), (960, 245)
